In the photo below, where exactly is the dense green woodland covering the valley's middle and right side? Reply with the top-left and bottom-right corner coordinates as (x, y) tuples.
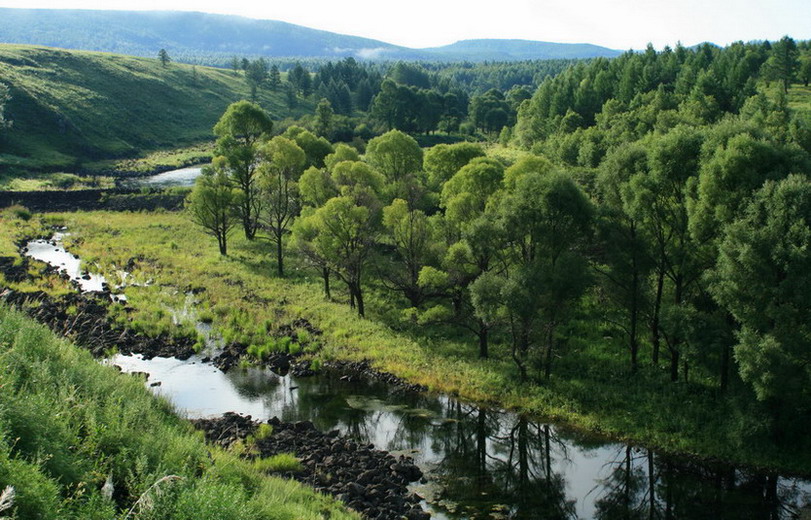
(189, 37), (811, 443)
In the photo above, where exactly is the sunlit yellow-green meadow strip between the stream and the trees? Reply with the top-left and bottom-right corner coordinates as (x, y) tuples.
(22, 212), (811, 473)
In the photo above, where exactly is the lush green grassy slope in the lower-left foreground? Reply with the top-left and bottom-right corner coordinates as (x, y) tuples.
(0, 306), (358, 520)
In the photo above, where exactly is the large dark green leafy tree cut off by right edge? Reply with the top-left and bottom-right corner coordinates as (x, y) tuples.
(712, 175), (811, 441)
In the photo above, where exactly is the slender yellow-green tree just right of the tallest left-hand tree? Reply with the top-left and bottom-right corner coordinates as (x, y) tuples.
(258, 136), (306, 276)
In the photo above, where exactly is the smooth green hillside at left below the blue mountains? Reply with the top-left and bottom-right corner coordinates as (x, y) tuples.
(0, 45), (312, 172)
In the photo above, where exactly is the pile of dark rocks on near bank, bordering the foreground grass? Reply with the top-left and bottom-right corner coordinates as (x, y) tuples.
(192, 413), (431, 520)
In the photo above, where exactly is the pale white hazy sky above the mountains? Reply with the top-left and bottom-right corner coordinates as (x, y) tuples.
(0, 0), (811, 50)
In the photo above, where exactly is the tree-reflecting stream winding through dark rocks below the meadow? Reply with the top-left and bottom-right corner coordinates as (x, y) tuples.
(20, 240), (811, 520)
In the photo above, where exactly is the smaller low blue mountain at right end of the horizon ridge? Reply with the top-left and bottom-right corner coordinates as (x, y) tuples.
(423, 40), (621, 61)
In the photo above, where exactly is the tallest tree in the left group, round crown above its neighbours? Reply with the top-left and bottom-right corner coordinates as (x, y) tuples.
(214, 101), (273, 240)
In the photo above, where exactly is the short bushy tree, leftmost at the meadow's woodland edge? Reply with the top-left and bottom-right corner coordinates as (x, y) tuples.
(186, 157), (239, 255)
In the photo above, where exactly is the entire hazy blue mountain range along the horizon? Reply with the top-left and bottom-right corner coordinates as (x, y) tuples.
(0, 8), (619, 65)
